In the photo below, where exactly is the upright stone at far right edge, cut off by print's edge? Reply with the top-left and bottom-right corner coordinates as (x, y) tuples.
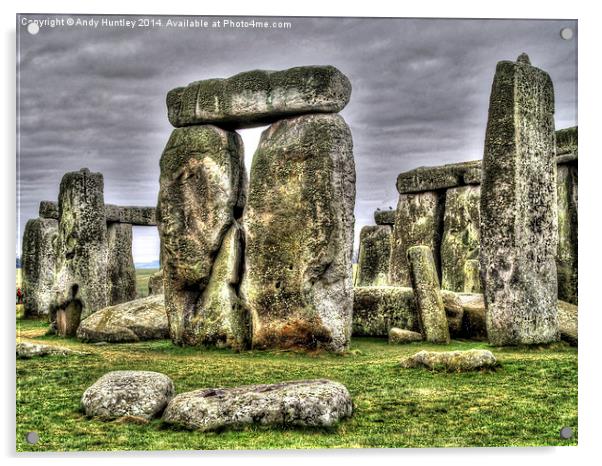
(556, 163), (578, 304)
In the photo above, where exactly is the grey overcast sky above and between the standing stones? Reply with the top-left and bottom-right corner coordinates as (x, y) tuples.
(17, 15), (577, 262)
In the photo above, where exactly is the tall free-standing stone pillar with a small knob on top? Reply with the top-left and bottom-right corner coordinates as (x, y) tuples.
(480, 54), (559, 345)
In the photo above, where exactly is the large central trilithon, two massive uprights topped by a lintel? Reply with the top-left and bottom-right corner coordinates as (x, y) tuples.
(157, 66), (355, 351)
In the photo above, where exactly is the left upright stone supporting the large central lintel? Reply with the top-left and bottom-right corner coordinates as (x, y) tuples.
(157, 126), (246, 345)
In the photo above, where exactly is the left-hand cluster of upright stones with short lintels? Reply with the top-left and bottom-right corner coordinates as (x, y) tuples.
(22, 168), (156, 336)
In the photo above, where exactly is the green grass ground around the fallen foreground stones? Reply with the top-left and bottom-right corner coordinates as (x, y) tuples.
(17, 320), (577, 451)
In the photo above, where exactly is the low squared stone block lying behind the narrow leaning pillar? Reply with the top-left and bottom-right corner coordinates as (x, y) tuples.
(353, 286), (464, 337)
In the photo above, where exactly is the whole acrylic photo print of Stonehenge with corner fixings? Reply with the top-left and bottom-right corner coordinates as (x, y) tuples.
(16, 14), (578, 452)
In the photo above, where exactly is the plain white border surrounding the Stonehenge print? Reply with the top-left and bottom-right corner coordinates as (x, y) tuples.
(0, 0), (602, 466)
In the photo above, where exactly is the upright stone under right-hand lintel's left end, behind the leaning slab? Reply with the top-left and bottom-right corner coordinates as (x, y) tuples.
(389, 191), (445, 286)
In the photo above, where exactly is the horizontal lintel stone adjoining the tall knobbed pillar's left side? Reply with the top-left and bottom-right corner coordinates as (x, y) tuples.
(397, 160), (481, 194)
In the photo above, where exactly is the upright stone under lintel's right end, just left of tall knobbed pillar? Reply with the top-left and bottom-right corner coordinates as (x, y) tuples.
(441, 186), (481, 291)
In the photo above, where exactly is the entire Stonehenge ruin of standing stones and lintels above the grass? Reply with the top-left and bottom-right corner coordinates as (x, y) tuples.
(17, 55), (578, 352)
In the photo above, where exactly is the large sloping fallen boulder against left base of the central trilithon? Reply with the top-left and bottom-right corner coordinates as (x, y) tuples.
(77, 295), (169, 343)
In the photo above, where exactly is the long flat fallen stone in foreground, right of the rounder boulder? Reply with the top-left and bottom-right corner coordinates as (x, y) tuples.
(163, 380), (353, 431)
